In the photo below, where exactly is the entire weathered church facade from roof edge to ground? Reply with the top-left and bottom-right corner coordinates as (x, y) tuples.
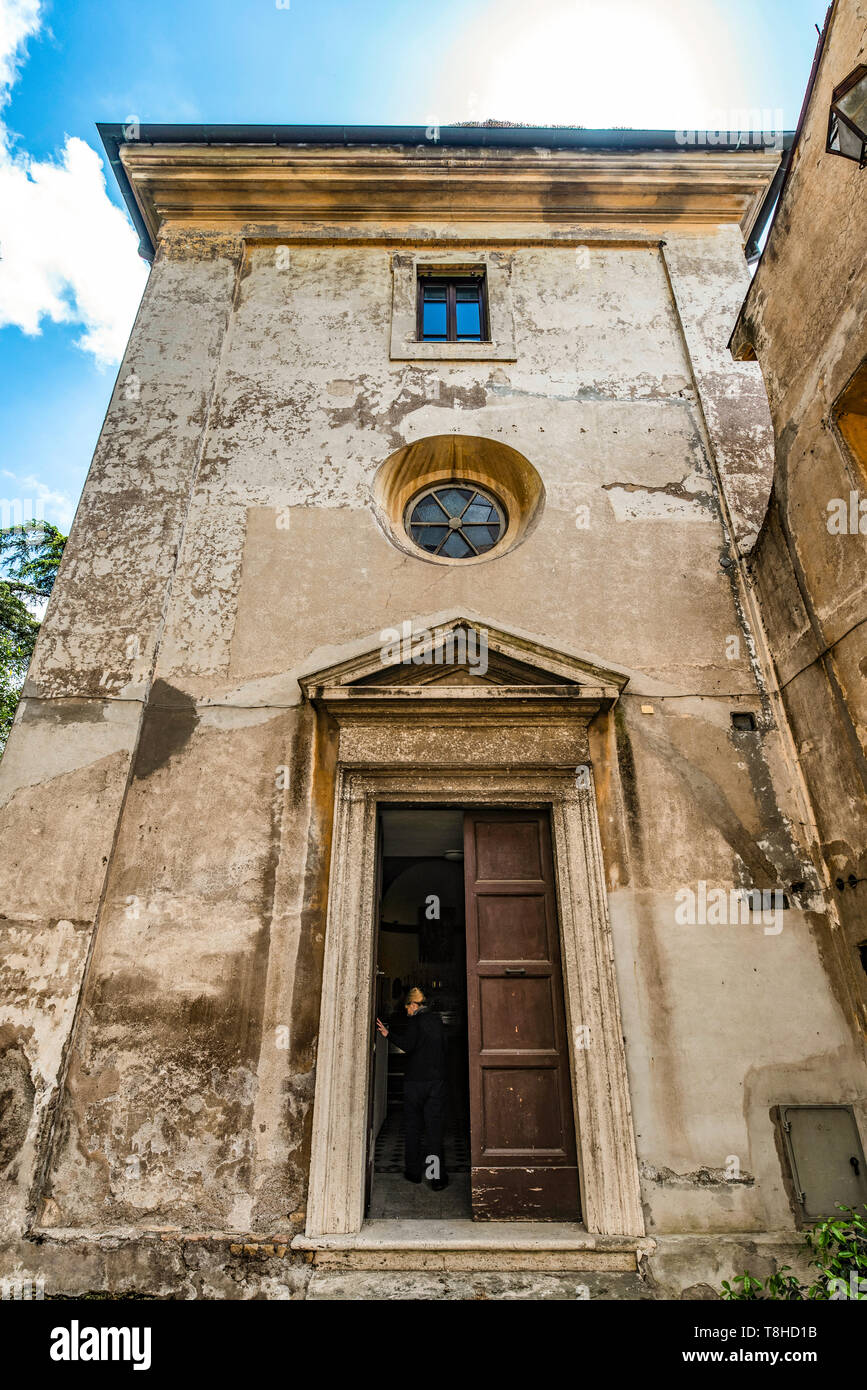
(0, 113), (867, 1298)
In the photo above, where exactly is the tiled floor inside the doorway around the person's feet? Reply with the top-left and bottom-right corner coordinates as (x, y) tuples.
(367, 1105), (471, 1220)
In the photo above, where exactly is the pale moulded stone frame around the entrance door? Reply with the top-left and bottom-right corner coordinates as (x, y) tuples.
(306, 763), (645, 1237)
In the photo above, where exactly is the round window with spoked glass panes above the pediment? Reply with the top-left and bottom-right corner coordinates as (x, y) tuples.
(406, 482), (506, 560)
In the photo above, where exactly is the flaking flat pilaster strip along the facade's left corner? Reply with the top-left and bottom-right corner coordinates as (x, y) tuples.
(0, 230), (244, 1251)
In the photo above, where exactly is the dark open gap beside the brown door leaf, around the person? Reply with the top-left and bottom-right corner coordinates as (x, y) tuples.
(367, 806), (471, 1219)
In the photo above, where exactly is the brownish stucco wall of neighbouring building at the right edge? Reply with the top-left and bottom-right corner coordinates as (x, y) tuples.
(734, 0), (867, 1045)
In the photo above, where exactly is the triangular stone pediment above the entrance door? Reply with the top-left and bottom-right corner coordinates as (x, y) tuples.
(302, 617), (627, 703)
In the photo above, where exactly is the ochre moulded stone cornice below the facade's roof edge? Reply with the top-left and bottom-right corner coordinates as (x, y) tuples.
(119, 142), (779, 250)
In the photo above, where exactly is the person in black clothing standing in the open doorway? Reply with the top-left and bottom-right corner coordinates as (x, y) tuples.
(377, 988), (449, 1193)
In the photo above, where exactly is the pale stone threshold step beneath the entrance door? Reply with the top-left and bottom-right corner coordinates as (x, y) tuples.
(292, 1220), (647, 1273)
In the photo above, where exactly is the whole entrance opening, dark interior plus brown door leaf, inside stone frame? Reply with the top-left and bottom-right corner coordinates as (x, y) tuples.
(365, 806), (584, 1220)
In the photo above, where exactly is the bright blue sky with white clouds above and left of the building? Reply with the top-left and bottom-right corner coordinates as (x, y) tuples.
(0, 0), (827, 528)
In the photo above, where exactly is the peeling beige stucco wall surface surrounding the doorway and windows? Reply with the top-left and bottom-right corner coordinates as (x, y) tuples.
(0, 138), (864, 1293)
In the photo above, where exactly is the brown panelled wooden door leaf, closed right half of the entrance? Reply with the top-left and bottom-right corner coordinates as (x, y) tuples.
(464, 810), (579, 1220)
